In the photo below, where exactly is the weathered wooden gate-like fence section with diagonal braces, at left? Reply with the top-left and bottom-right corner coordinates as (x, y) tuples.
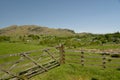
(0, 45), (63, 80)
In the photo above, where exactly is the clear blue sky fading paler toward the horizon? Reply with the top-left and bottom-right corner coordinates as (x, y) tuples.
(0, 0), (120, 33)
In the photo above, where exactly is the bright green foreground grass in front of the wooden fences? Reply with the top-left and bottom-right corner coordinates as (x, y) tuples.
(31, 64), (120, 80)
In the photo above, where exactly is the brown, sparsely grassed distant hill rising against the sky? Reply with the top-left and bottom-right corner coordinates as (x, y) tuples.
(0, 25), (75, 36)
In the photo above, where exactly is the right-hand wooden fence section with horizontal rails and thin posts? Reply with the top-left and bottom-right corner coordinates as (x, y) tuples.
(62, 50), (120, 69)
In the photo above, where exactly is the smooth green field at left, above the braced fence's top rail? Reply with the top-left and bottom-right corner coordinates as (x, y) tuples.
(0, 42), (45, 55)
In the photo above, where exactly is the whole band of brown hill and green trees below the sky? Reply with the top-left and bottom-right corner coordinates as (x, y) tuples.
(0, 25), (120, 48)
